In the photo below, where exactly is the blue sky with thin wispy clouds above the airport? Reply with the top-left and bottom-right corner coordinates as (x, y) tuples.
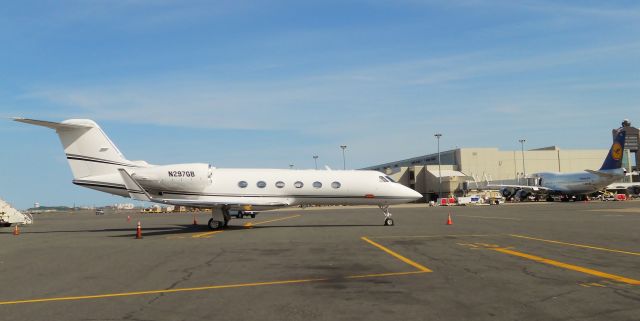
(0, 0), (640, 208)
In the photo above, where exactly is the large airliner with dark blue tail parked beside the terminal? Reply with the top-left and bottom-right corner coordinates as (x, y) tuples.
(487, 127), (626, 200)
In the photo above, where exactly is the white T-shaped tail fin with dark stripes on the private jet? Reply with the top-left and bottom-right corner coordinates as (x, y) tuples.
(14, 118), (139, 179)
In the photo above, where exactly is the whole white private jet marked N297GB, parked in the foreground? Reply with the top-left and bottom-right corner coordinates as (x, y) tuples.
(14, 118), (422, 229)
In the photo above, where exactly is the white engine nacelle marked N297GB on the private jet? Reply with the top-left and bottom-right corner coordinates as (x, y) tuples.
(131, 163), (213, 191)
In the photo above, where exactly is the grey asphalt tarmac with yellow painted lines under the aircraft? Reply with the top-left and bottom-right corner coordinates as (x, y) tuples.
(0, 201), (640, 321)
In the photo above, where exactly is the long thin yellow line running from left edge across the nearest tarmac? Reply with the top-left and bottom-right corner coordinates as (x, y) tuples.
(0, 271), (430, 305)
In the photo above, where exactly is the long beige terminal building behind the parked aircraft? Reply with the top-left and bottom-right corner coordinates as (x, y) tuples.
(364, 123), (640, 200)
